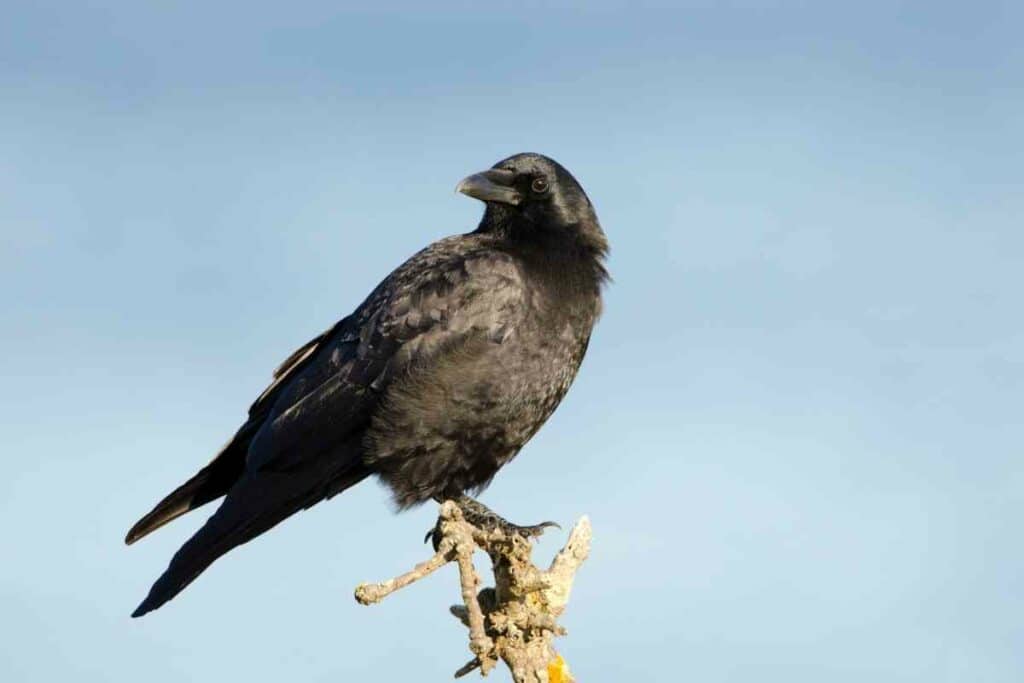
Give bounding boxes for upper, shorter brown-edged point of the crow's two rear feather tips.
[125,444,248,546]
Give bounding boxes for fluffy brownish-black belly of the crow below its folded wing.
[365,299,593,507]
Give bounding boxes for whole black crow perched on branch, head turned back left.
[125,153,609,616]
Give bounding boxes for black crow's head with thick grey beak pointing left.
[456,154,608,257]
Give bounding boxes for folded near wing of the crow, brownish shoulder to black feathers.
[241,241,526,471]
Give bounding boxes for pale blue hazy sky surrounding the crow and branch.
[0,0,1024,683]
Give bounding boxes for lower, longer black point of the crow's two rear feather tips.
[132,467,369,616]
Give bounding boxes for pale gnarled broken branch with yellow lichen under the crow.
[355,501,591,683]
